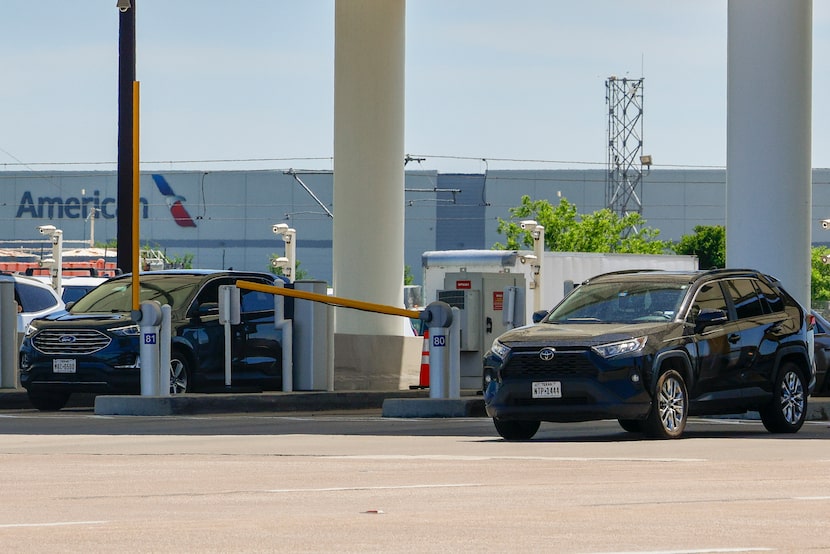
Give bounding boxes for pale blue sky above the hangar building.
[0,0,830,172]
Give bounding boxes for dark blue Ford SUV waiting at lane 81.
[19,270,282,410]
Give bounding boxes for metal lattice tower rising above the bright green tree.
[605,76,651,217]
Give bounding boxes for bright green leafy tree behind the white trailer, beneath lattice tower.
[493,195,670,254]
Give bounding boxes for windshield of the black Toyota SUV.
[544,280,688,323]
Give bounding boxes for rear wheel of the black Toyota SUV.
[759,362,807,433]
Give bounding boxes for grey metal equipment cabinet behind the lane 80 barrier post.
[436,271,527,390]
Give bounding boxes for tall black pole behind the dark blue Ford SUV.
[116,0,136,272]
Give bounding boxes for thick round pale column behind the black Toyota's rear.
[726,0,812,306]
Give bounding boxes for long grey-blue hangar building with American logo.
[0,169,830,284]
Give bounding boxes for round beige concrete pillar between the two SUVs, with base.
[332,0,406,335]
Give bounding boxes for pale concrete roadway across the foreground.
[0,409,830,553]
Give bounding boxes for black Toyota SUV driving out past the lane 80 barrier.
[484,270,816,440]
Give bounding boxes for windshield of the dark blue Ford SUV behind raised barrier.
[69,275,201,314]
